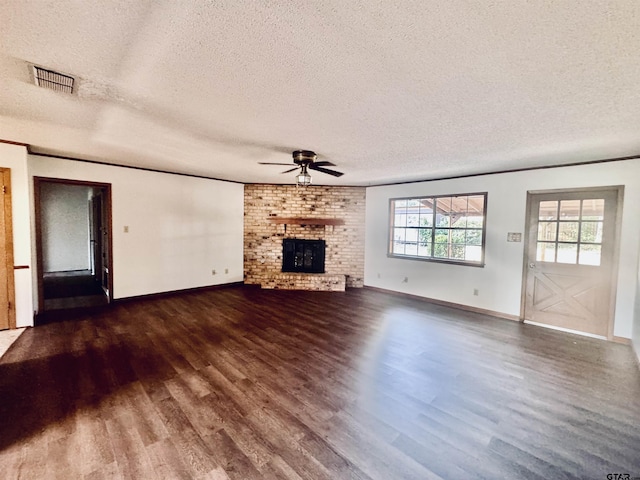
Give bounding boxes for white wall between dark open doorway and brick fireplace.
[28,155,244,304]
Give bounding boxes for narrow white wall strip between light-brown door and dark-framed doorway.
[0,143,33,327]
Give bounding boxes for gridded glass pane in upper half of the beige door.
[536,198,604,266]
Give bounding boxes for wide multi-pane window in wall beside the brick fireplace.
[389,193,487,266]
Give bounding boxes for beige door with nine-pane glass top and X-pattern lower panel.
[524,187,618,337]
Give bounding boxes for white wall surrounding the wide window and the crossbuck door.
[365,160,640,338]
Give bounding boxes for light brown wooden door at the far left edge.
[0,168,15,330]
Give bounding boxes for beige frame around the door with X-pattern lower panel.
[520,185,624,341]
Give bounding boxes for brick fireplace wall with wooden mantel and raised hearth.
[244,185,365,291]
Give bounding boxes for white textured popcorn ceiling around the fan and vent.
[0,0,640,185]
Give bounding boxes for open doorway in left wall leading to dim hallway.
[34,177,113,315]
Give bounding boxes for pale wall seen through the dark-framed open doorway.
[40,182,91,272]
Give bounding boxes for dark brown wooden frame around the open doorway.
[33,177,113,314]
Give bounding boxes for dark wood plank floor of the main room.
[0,287,640,480]
